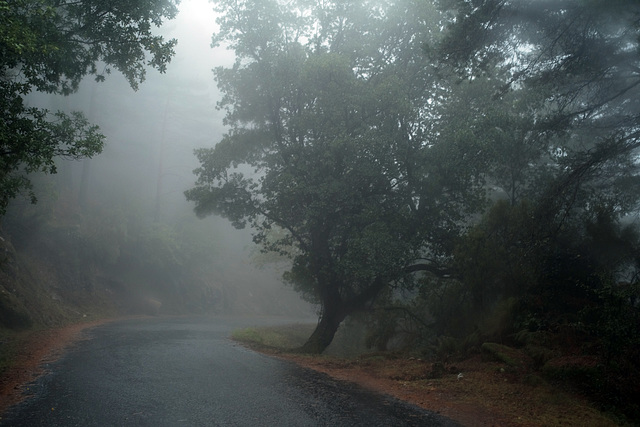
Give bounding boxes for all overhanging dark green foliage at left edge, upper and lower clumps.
[0,0,177,214]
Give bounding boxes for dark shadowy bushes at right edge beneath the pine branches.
[420,194,638,374]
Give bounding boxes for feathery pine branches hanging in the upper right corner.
[439,0,640,218]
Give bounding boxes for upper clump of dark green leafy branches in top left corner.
[0,0,177,94]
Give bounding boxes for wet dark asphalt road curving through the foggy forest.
[0,318,456,427]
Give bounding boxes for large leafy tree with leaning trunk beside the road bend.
[186,0,484,353]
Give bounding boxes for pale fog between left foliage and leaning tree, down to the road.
[5,0,314,317]
